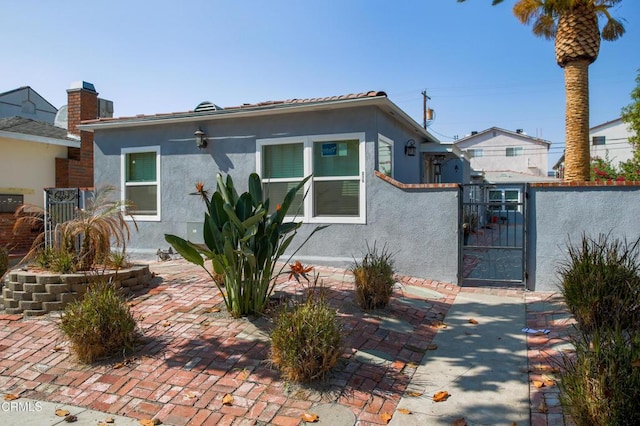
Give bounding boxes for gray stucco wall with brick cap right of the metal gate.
[528,186,640,291]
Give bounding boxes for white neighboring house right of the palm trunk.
[589,118,633,166]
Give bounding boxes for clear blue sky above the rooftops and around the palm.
[0,0,640,167]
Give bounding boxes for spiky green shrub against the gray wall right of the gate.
[560,235,640,333]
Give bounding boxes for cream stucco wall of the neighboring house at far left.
[0,138,67,207]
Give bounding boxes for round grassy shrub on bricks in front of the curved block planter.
[59,281,136,363]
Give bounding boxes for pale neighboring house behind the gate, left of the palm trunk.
[455,127,551,182]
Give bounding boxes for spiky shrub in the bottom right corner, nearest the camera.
[560,329,640,426]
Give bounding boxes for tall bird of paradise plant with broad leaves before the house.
[165,173,324,317]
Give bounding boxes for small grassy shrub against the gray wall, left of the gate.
[351,243,395,309]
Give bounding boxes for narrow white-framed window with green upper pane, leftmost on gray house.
[120,146,160,221]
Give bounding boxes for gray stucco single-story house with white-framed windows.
[79,92,470,282]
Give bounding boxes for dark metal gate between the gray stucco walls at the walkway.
[458,184,528,284]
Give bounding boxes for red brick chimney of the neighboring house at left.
[56,81,98,188]
